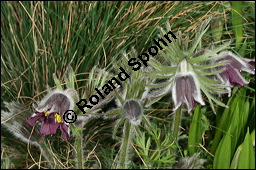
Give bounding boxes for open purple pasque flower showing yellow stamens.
[27,89,76,140]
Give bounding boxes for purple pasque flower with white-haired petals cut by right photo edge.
[216,51,255,97]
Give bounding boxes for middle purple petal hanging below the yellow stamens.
[40,118,59,136]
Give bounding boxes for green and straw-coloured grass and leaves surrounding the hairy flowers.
[1,1,255,168]
